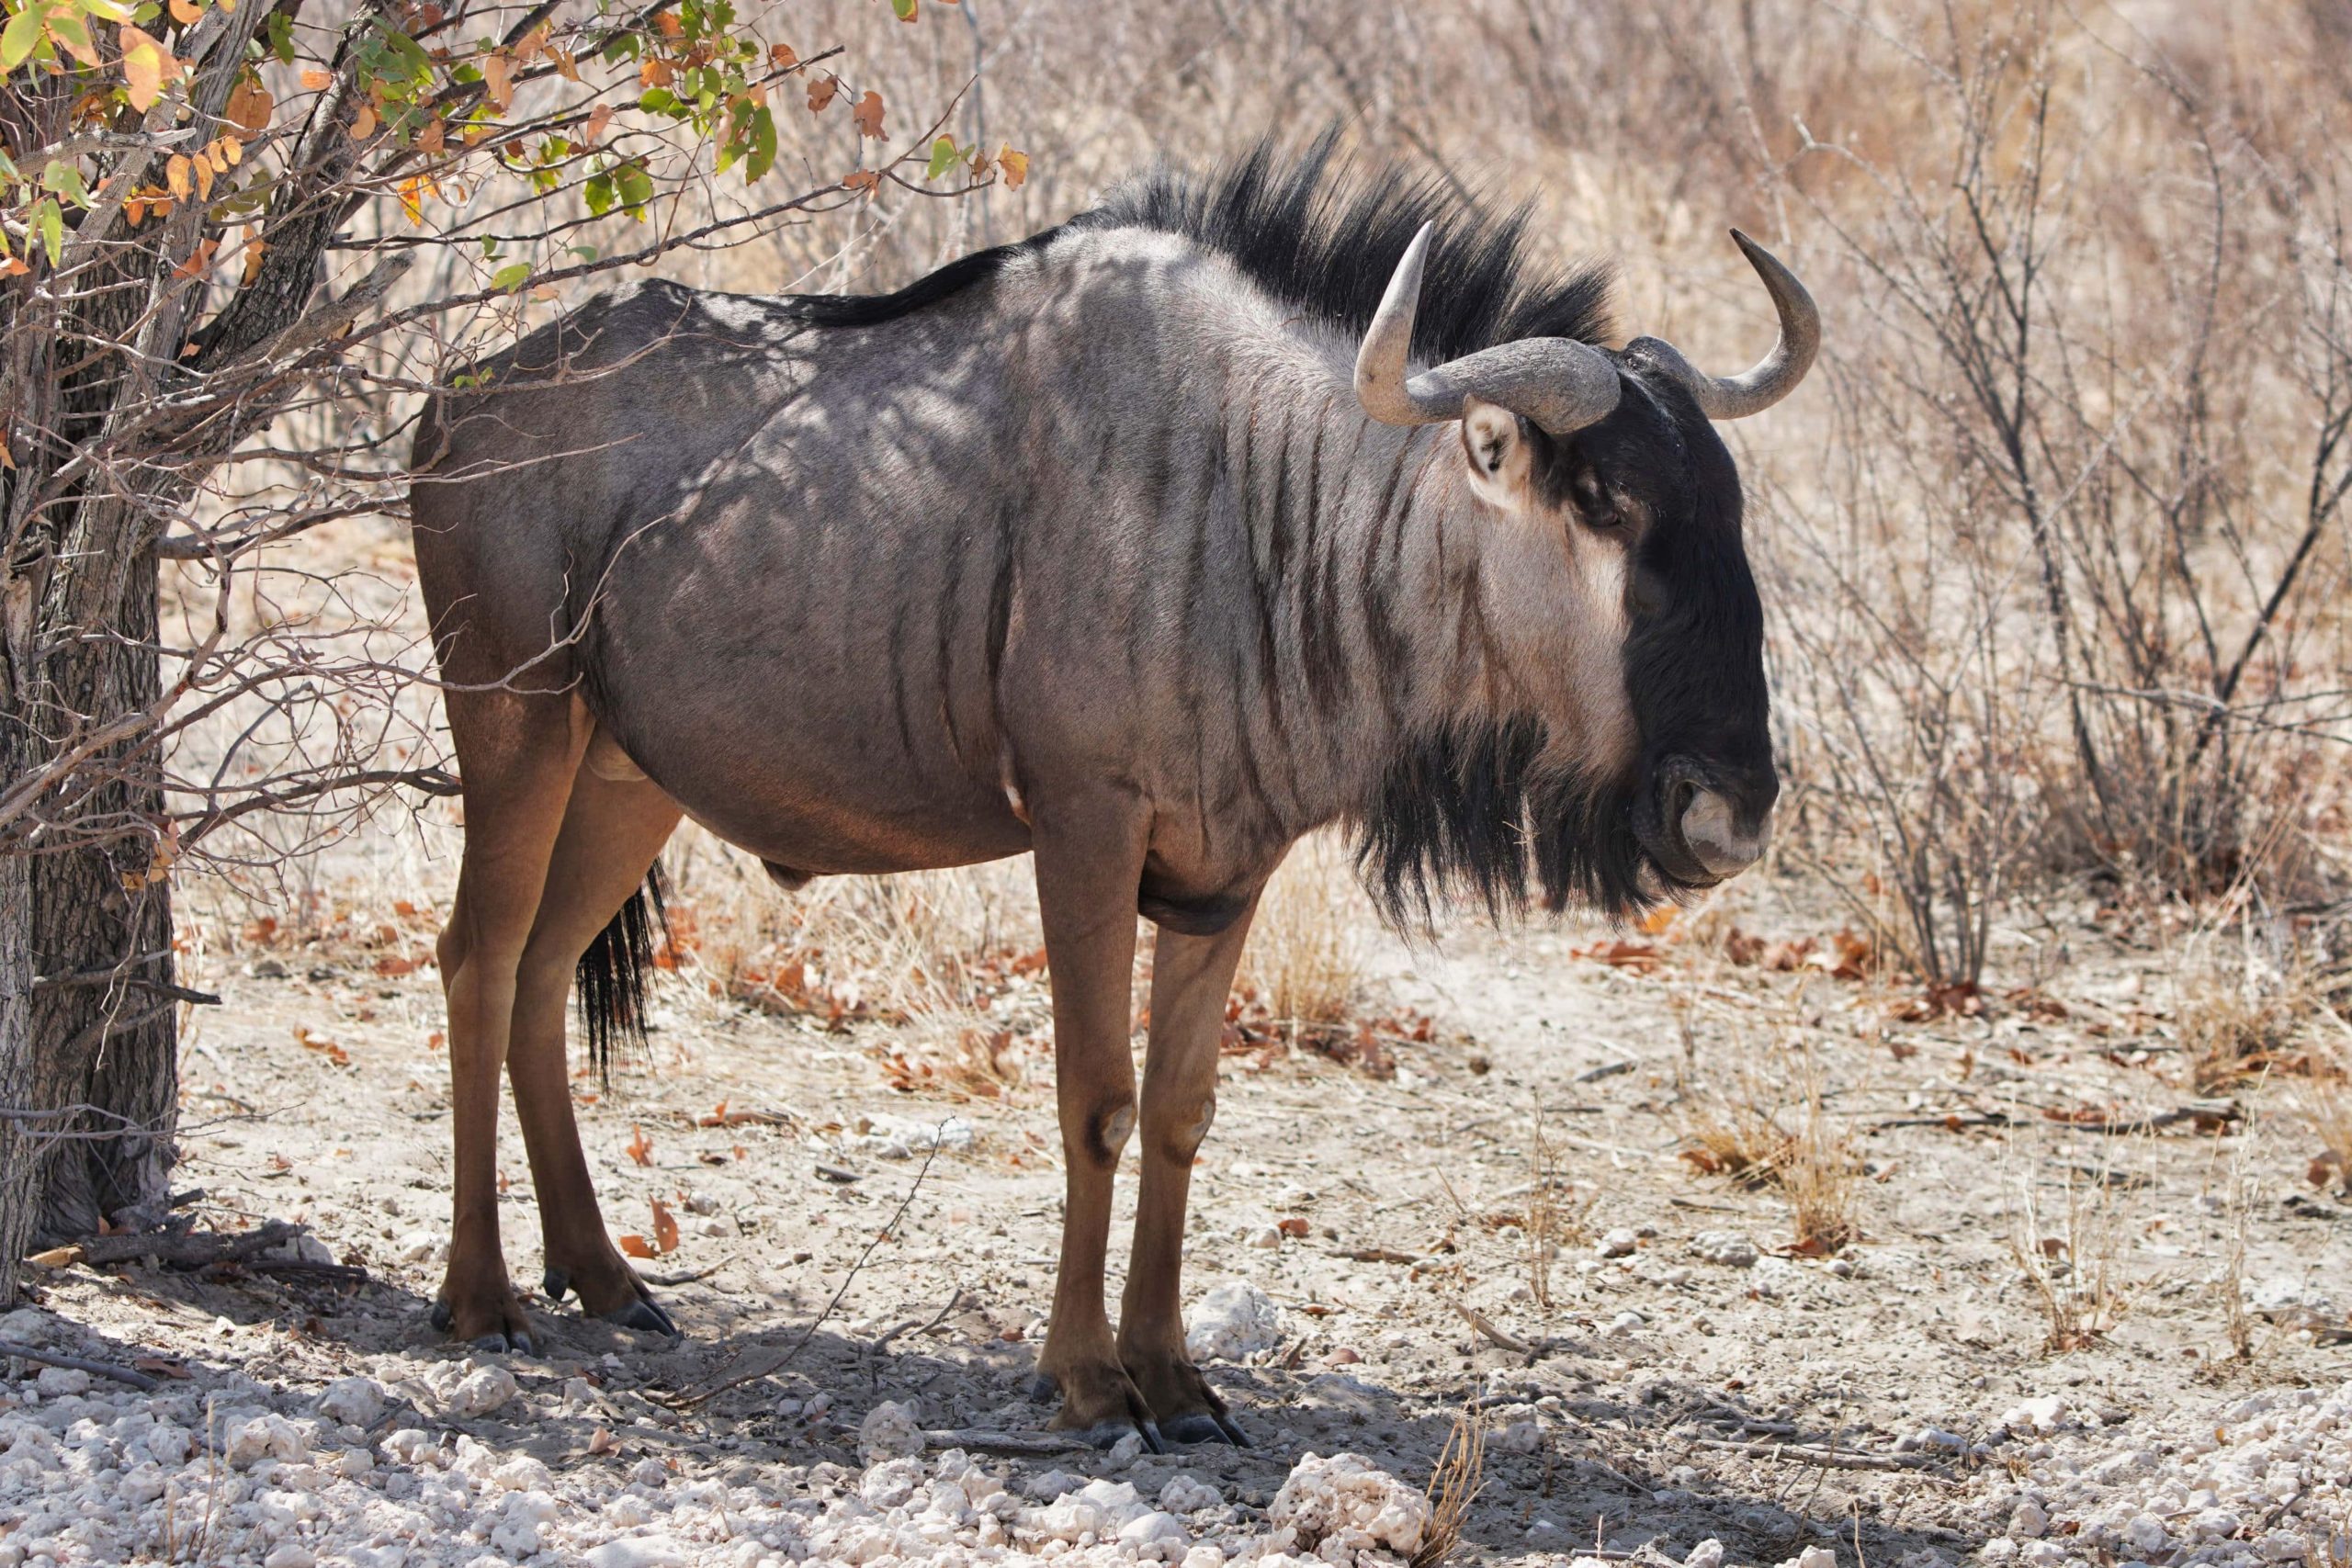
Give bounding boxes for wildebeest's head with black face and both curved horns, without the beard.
[1355,228,1820,888]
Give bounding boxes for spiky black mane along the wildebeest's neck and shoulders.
[788,131,1613,360]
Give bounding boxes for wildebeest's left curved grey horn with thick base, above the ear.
[1355,223,1618,434]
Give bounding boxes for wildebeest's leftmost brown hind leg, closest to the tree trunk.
[433,691,588,1352]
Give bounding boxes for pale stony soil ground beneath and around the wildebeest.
[0,869,2352,1568]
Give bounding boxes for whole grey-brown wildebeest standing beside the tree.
[414,146,1818,1443]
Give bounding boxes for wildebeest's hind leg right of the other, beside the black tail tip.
[505,743,680,1333]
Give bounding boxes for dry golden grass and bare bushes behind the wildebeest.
[172,0,2352,1135]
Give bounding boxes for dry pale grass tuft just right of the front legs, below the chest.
[1239,832,1369,1034]
